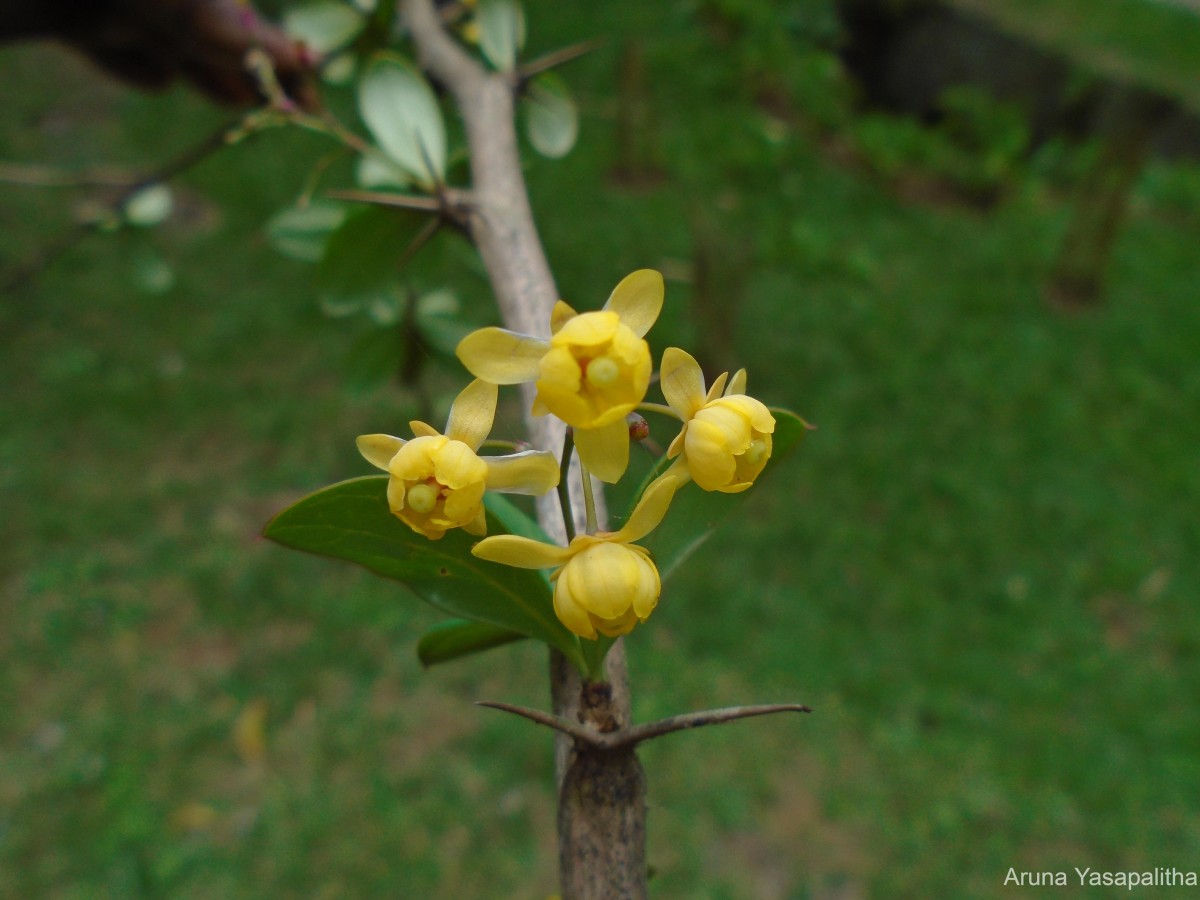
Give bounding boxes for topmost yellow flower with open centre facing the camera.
[457,269,662,484]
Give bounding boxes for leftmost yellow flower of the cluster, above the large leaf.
[358,380,558,540]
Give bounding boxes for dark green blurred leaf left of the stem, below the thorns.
[317,206,428,316]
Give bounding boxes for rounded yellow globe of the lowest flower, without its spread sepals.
[554,540,662,640]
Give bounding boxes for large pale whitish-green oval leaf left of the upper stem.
[359,53,446,191]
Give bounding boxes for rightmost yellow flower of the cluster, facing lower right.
[660,347,775,493]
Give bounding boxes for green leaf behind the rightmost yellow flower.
[637,409,809,580]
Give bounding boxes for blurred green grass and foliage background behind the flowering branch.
[0,0,1200,898]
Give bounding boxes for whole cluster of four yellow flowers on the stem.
[358,269,775,640]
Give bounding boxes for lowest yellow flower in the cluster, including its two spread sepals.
[470,476,682,641]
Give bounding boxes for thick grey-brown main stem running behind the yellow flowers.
[400,0,646,900]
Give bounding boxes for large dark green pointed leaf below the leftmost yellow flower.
[263,475,583,668]
